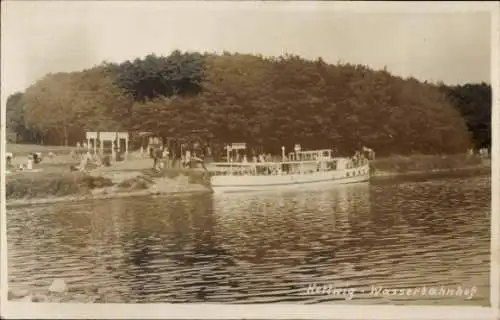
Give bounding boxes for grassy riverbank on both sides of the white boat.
[6,151,491,205]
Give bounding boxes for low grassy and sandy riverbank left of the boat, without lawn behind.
[6,167,210,206]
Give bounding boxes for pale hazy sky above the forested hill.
[1,0,491,109]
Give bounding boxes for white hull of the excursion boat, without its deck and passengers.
[211,165,370,193]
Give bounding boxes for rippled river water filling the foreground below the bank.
[7,176,491,306]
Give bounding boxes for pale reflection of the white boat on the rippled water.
[212,183,370,265]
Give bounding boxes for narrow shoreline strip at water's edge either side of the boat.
[6,164,491,208]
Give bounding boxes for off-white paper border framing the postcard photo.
[0,1,500,320]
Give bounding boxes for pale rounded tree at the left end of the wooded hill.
[24,68,132,146]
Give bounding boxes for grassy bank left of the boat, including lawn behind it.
[6,144,210,206]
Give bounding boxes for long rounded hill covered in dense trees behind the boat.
[7,51,491,155]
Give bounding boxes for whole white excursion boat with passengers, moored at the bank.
[209,147,370,193]
